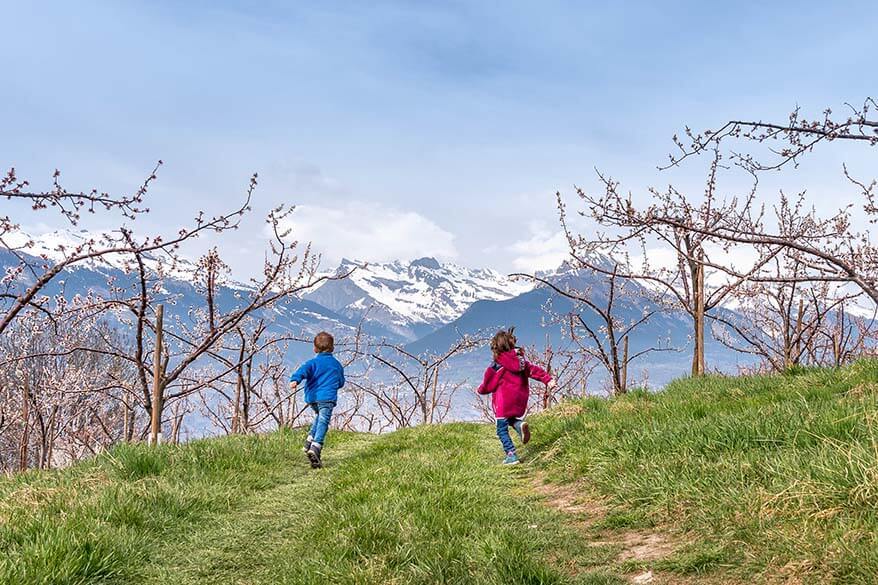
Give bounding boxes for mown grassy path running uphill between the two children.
[143,425,620,584]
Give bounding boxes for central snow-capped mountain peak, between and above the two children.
[305,258,533,340]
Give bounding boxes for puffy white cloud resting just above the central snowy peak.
[280,201,457,263]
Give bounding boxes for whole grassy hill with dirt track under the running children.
[0,362,878,584]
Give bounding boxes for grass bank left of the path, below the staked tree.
[0,433,364,584]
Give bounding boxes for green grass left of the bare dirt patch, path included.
[0,424,621,584]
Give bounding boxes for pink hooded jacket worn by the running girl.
[478,350,552,418]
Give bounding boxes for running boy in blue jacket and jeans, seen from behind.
[290,331,344,469]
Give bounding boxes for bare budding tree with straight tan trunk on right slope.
[557,146,780,376]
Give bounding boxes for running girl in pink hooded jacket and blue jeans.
[478,327,555,465]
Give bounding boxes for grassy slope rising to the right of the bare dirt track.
[530,361,878,583]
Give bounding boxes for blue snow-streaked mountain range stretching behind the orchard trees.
[0,232,756,400]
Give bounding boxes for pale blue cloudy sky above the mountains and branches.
[0,0,878,272]
